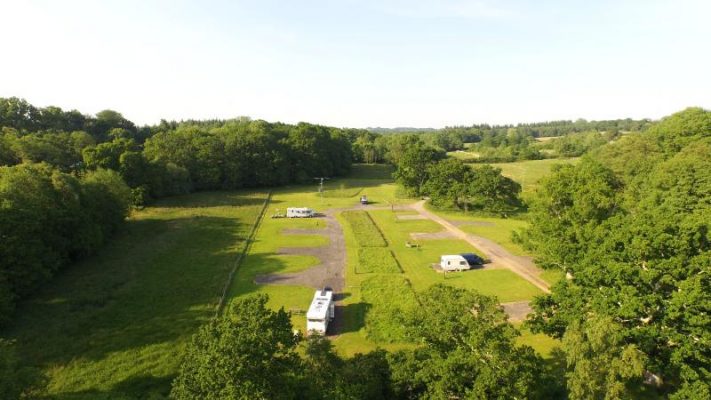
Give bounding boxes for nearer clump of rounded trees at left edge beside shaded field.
[0,164,130,322]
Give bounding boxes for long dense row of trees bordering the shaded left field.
[0,98,352,330]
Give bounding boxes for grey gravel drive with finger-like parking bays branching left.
[254,210,346,293]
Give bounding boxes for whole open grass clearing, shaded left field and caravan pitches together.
[4,162,556,399]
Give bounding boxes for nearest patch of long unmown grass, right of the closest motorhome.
[361,274,417,343]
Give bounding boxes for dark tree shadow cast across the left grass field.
[2,216,248,372]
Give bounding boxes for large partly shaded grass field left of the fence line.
[3,192,265,399]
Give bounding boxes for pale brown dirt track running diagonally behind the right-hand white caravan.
[411,200,551,293]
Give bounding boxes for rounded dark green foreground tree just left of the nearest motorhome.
[171,295,299,400]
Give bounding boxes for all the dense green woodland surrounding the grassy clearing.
[0,98,711,399]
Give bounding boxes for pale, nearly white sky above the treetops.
[0,0,711,127]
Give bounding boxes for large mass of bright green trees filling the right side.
[524,109,711,398]
